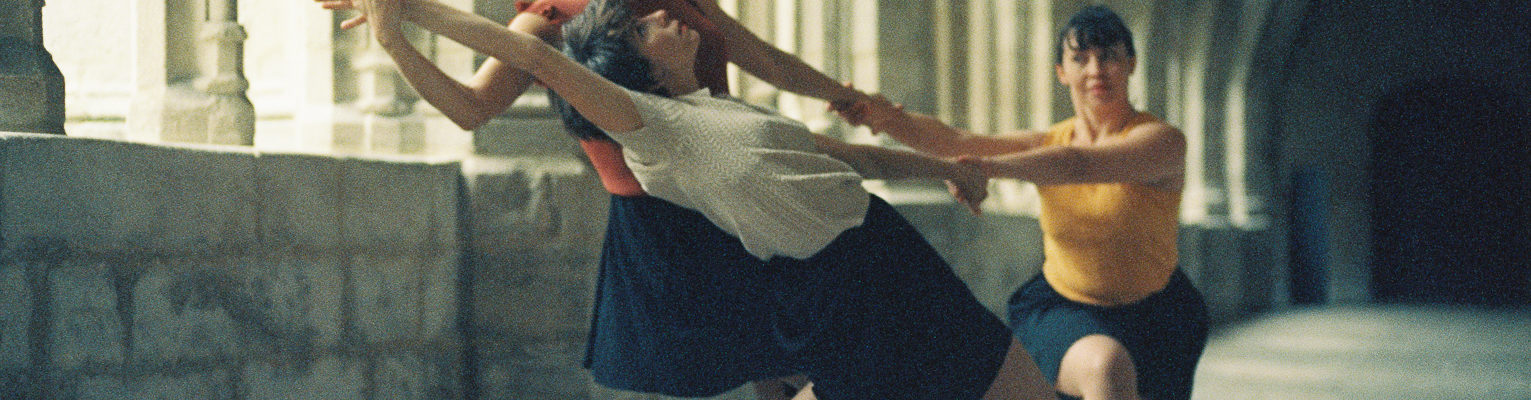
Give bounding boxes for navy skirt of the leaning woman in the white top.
[769,196,1010,400]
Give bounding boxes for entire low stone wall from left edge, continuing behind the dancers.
[0,133,1274,400]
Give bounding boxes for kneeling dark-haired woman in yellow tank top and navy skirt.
[842,6,1206,400]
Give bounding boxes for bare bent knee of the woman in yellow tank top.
[1058,334,1138,400]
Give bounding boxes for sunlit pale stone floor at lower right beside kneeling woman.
[1193,305,1531,400]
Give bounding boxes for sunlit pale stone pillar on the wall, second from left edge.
[127,0,256,146]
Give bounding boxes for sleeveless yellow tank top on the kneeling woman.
[1036,112,1180,305]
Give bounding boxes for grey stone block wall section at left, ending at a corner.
[0,135,464,398]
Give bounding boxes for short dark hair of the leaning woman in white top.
[548,0,669,139]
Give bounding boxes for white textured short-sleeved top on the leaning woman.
[608,90,870,259]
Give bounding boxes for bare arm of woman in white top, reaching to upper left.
[354,0,643,132]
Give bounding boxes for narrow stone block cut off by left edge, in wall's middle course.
[0,262,32,367]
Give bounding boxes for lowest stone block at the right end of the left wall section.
[372,356,462,400]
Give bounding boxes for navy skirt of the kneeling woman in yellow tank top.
[1009,270,1208,400]
